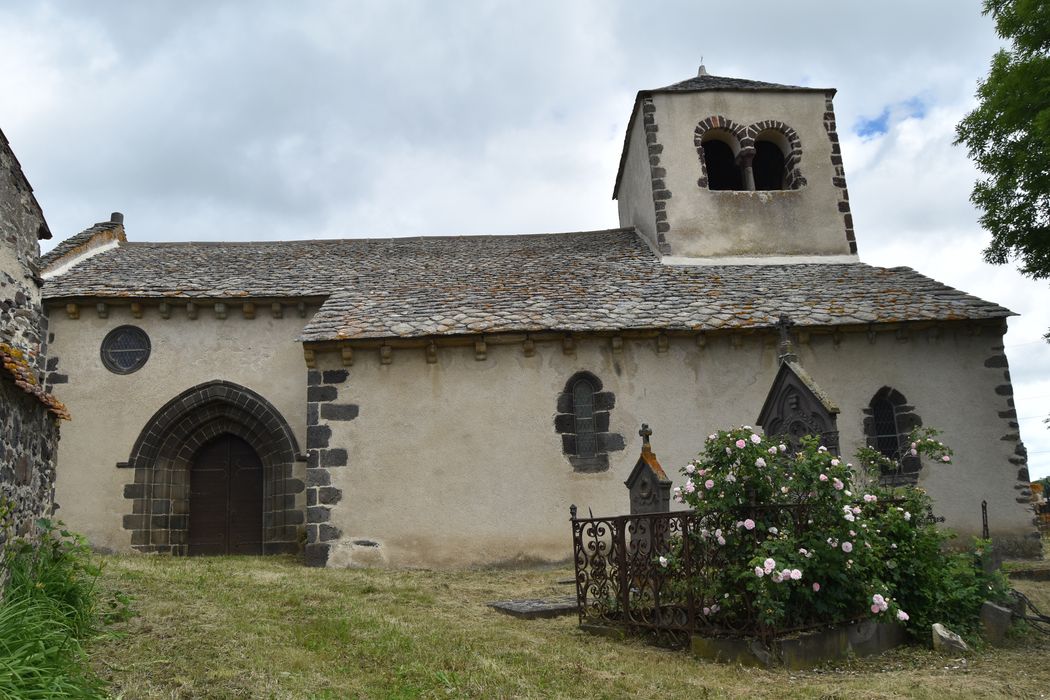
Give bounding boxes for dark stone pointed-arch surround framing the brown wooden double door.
[117,380,305,554]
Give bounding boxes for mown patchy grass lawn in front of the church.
[91,556,1050,699]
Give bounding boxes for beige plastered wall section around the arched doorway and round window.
[50,302,314,551]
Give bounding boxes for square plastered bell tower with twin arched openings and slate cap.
[612,66,857,264]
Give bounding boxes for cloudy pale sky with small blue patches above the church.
[0,0,1050,476]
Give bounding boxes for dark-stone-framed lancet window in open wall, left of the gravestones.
[554,372,625,471]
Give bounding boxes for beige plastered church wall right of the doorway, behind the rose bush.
[318,326,1032,567]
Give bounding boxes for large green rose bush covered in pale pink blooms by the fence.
[659,426,1005,638]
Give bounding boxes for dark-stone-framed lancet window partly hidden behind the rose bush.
[864,386,922,486]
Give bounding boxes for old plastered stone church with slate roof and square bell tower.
[26,68,1038,567]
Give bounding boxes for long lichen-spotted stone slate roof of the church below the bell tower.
[38,229,1010,341]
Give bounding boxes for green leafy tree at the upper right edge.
[956,0,1050,304]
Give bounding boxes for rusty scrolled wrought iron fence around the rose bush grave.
[571,501,907,646]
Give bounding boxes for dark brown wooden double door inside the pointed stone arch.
[189,434,263,555]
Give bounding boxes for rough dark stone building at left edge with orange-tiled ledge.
[0,132,61,558]
